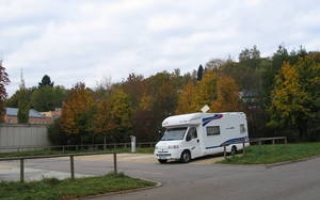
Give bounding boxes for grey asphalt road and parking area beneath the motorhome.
[0,155,320,200]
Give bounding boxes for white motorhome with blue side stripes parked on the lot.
[154,112,248,163]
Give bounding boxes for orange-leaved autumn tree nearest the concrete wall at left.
[61,82,95,143]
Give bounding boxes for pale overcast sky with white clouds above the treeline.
[0,0,320,95]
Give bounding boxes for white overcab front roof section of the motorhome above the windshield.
[162,112,212,127]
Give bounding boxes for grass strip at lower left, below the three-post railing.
[0,174,155,200]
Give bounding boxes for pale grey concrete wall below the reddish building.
[0,124,50,152]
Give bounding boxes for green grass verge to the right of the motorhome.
[220,143,320,164]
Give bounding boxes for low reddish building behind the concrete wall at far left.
[4,107,57,124]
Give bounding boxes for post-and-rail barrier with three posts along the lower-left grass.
[0,152,118,182]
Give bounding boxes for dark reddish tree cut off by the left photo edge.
[0,60,10,121]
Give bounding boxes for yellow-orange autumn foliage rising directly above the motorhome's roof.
[176,70,240,114]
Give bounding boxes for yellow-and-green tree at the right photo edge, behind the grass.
[268,58,320,139]
